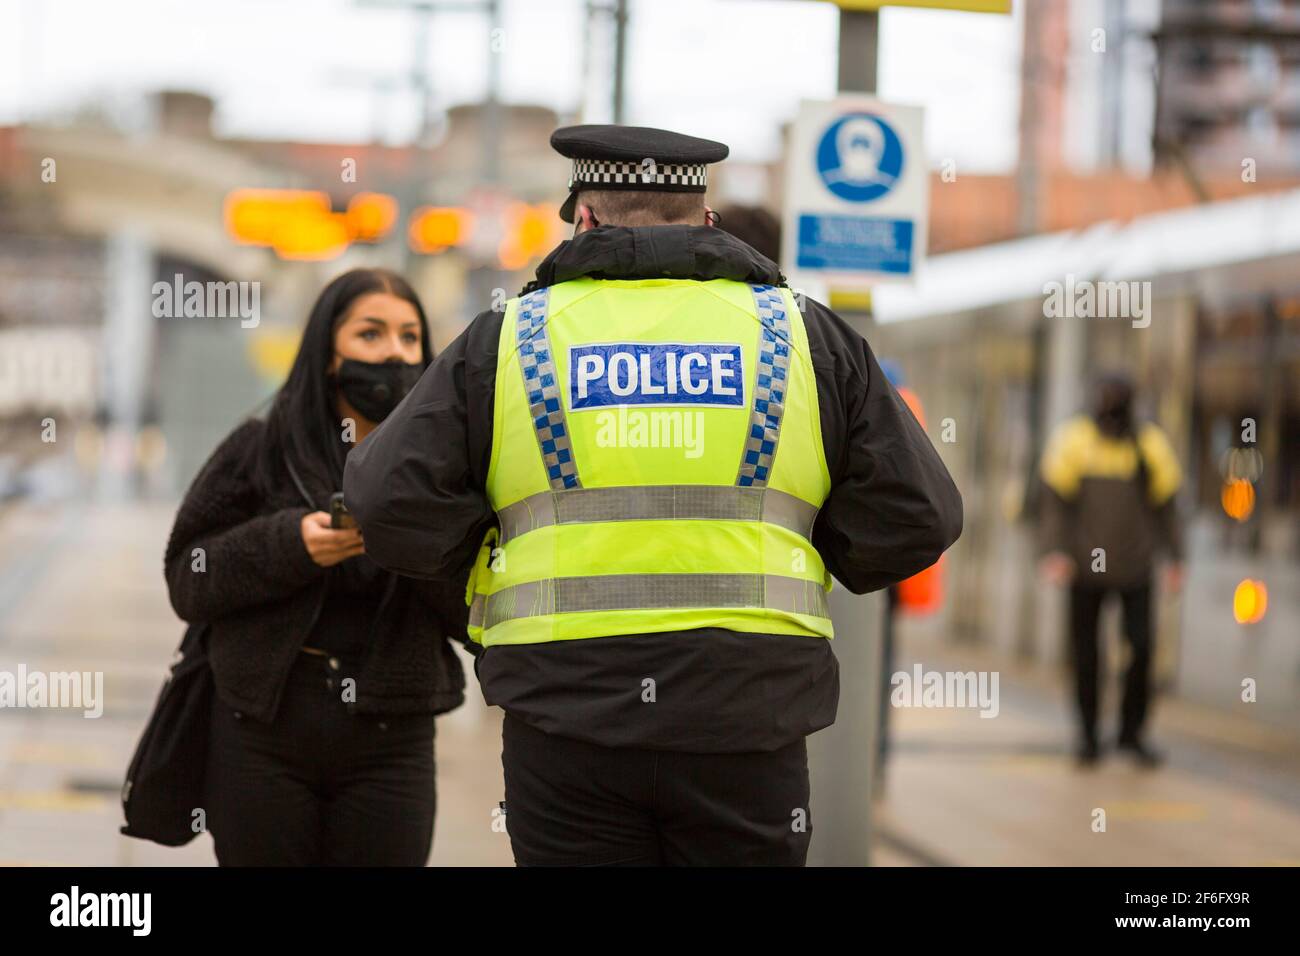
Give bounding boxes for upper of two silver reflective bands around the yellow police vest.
[497,485,818,544]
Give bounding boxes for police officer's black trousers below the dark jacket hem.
[502,704,813,866]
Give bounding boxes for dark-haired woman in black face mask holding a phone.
[165,269,467,866]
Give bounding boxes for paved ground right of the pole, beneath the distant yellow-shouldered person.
[868,632,1300,866]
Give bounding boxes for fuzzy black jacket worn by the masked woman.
[164,420,468,722]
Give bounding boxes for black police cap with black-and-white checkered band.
[551,125,729,222]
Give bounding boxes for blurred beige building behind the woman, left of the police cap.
[0,91,567,497]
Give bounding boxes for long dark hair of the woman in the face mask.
[257,269,433,509]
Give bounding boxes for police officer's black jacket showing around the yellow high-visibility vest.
[343,226,962,753]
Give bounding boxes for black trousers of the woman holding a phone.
[207,653,437,866]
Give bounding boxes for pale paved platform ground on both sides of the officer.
[0,503,1300,866]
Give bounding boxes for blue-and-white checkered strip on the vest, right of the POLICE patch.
[736,285,790,488]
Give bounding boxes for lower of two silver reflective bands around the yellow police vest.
[488,574,831,628]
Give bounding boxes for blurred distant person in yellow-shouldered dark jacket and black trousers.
[1040,372,1183,766]
